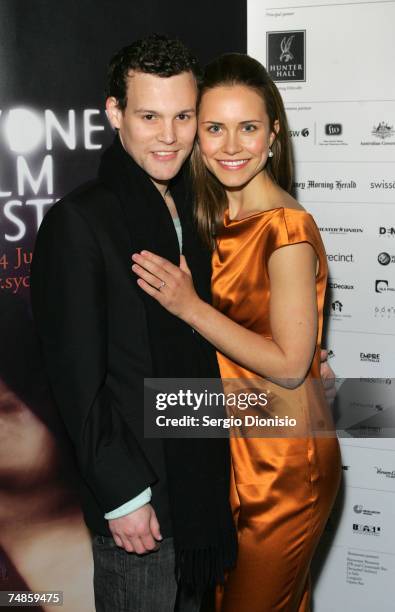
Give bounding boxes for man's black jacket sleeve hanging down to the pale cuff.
[31,201,156,513]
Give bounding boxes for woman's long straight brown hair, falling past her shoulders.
[191,53,293,249]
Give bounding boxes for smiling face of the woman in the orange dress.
[198,85,278,188]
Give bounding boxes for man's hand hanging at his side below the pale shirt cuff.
[108,504,162,555]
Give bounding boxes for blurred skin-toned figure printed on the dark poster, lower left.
[0,293,95,612]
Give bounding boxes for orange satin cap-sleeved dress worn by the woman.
[212,208,341,612]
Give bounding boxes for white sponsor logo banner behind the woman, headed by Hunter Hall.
[247,0,395,612]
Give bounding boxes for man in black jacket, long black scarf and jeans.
[32,36,336,612]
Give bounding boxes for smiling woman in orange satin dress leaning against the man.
[133,54,340,612]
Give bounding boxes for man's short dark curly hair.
[106,34,201,110]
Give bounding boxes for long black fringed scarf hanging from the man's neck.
[99,137,237,588]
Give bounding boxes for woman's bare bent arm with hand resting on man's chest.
[133,243,317,388]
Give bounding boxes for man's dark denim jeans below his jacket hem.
[92,536,201,612]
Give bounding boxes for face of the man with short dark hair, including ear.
[106,72,197,190]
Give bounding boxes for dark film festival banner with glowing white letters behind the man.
[0,0,246,612]
